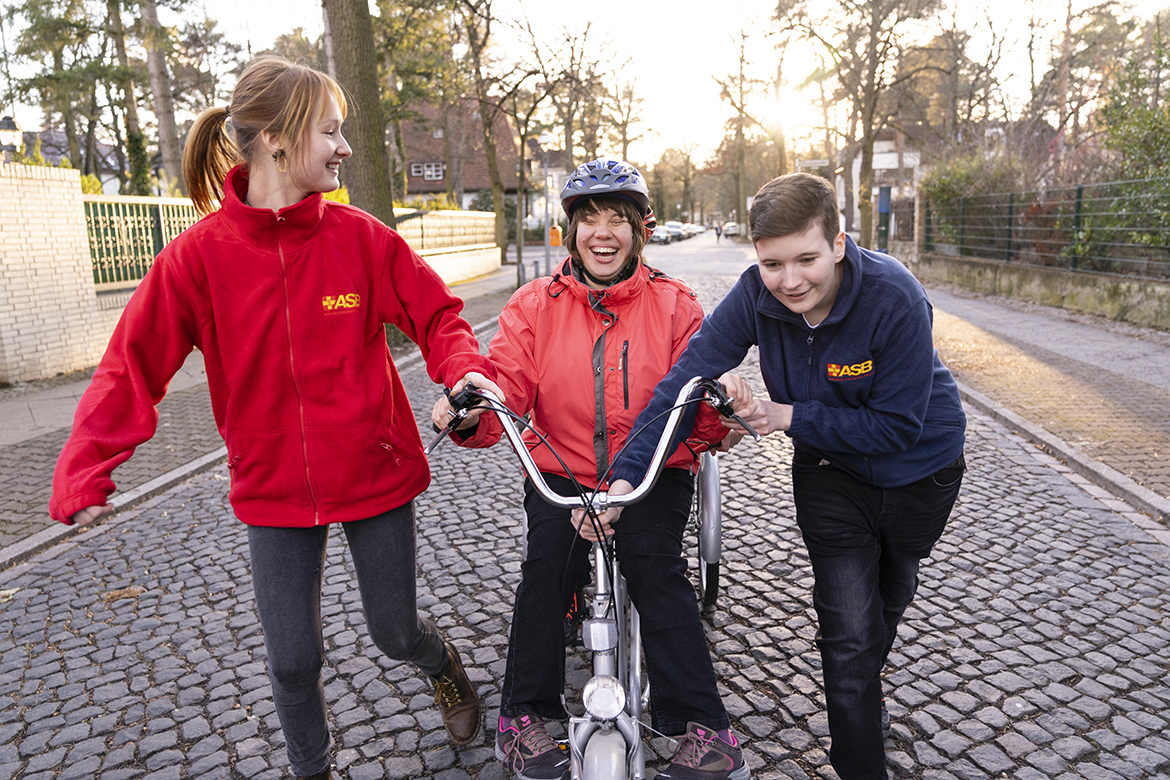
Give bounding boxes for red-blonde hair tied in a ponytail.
[183,56,346,214]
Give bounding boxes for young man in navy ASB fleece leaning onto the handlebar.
[603,173,966,780]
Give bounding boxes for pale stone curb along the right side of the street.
[956,382,1170,532]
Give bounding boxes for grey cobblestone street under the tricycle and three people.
[0,239,1170,780]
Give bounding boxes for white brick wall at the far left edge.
[0,164,110,382]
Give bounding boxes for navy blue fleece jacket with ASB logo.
[613,239,966,488]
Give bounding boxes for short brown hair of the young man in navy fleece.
[748,173,841,244]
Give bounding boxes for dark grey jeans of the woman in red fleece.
[248,504,447,778]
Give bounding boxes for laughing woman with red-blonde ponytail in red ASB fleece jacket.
[49,57,498,778]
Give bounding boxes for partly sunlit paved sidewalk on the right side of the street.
[932,288,1170,509]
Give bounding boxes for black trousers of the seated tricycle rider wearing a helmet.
[500,469,730,734]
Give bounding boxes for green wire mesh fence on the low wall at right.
[923,179,1170,279]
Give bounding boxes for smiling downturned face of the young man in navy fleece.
[756,222,845,325]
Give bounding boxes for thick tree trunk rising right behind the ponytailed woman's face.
[324,0,394,227]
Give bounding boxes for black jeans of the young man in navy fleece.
[792,453,965,780]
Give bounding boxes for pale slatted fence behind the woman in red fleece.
[82,195,496,292]
